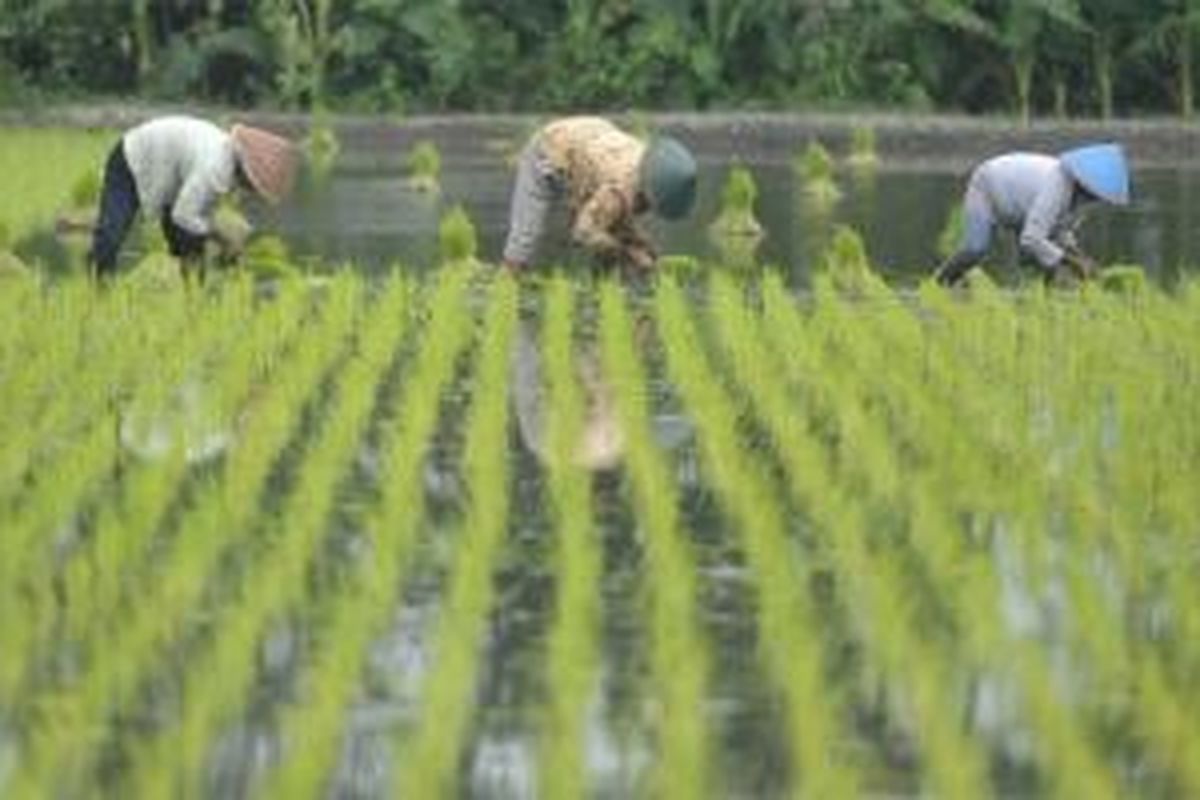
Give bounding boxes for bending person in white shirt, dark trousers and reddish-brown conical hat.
[89,116,296,277]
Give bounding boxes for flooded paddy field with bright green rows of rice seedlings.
[7,120,1200,799]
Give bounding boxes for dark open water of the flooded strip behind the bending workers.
[270,117,1200,284]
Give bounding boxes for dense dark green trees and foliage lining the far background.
[0,0,1200,118]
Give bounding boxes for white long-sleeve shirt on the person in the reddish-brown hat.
[122,116,236,236]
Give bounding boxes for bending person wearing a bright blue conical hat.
[937,144,1129,285]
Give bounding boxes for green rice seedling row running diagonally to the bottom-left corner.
[9,273,362,793]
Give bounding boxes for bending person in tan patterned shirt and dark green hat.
[504,116,696,270]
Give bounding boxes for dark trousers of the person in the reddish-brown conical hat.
[88,142,204,277]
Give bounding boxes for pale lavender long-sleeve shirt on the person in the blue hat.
[968,152,1081,266]
